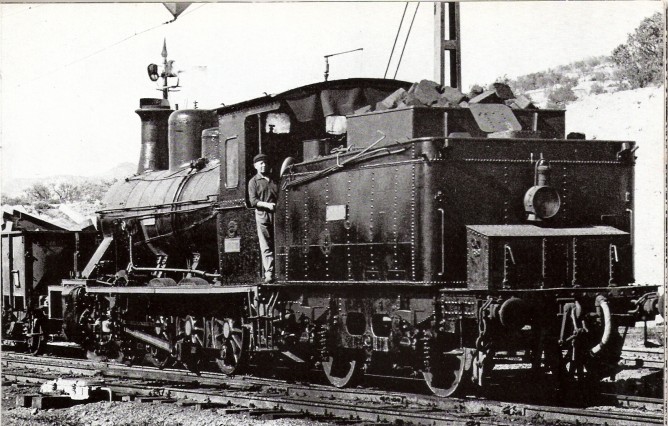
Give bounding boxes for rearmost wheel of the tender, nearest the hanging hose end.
[422,348,472,397]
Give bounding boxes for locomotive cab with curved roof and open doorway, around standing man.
[217,79,408,283]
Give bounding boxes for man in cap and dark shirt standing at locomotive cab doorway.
[248,153,278,283]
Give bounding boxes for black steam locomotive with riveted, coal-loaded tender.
[49,79,657,396]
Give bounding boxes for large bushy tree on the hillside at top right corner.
[612,12,663,89]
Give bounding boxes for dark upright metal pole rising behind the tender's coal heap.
[434,2,462,90]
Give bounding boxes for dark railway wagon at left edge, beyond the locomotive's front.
[0,210,97,353]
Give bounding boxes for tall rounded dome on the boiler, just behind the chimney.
[168,109,217,170]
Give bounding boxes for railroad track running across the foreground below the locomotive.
[2,353,663,425]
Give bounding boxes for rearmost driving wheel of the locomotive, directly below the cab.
[212,318,250,375]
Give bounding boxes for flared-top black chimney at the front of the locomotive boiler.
[135,98,173,174]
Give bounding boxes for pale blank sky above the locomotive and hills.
[0,1,662,181]
